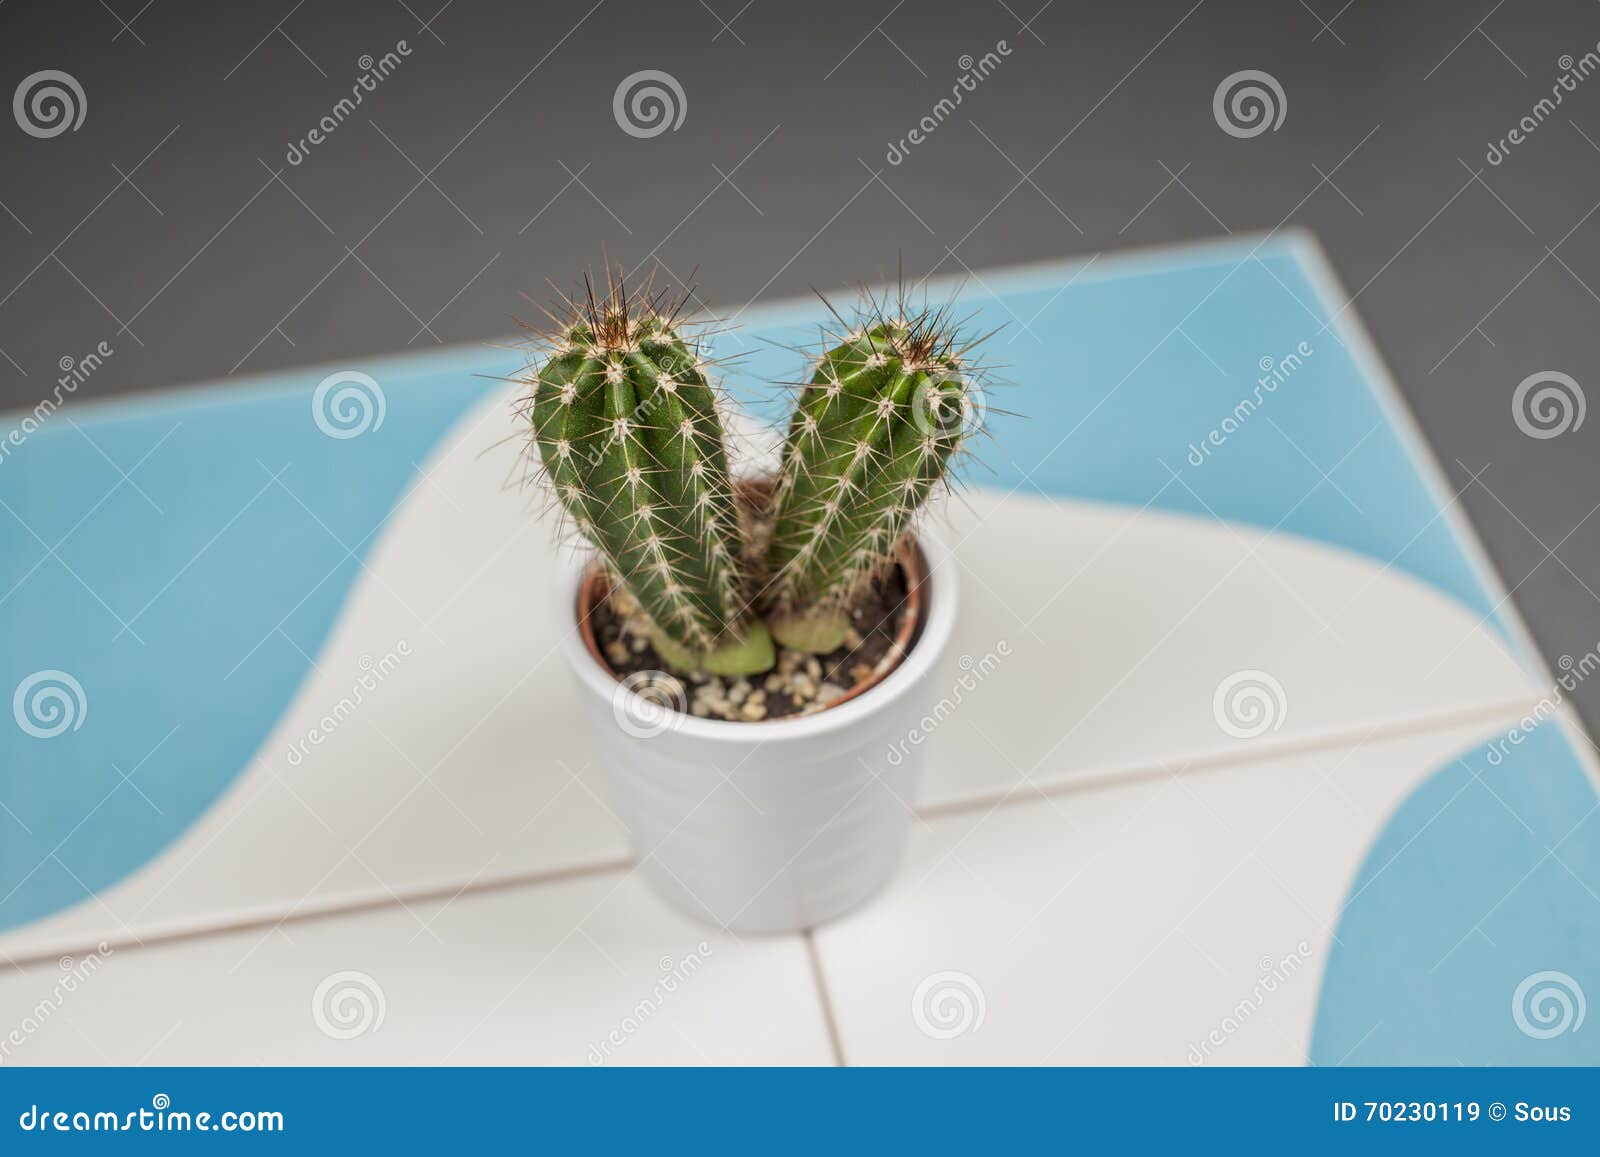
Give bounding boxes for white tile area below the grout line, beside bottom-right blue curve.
[818,723,1493,1064]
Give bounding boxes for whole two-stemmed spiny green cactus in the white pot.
[525,270,979,688]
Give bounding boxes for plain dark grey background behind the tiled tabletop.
[0,0,1600,730]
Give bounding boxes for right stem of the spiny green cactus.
[768,294,976,653]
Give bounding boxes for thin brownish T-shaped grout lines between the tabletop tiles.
[0,687,1538,966]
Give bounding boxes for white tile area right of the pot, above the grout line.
[923,491,1539,803]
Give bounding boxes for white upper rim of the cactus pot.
[560,530,957,746]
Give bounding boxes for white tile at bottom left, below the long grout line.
[0,871,832,1066]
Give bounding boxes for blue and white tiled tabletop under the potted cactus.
[0,237,1600,1064]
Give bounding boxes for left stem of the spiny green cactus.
[528,270,774,675]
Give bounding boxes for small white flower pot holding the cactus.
[558,533,957,933]
